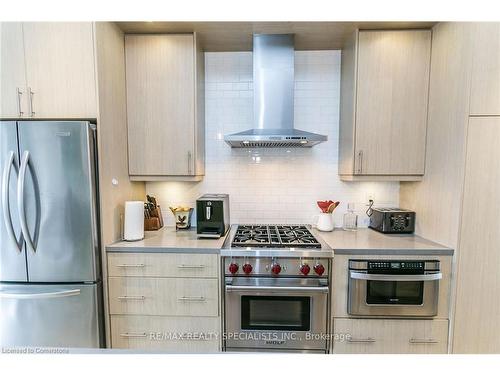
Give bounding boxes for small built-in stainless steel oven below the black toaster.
[348,259,443,317]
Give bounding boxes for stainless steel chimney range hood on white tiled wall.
[224,34,328,148]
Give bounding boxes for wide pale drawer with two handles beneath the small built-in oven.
[333,319,448,354]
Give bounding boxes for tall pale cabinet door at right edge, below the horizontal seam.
[453,117,500,353]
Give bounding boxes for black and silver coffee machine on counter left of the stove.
[196,194,230,238]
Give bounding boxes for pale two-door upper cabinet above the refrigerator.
[0,22,97,119]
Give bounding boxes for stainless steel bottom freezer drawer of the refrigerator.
[0,284,102,348]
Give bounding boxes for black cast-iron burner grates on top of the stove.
[231,225,321,248]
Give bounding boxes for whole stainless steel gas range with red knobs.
[221,225,333,353]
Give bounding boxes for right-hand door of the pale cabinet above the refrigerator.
[23,22,97,119]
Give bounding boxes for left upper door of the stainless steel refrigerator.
[0,121,28,281]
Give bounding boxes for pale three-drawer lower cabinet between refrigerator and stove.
[108,251,221,353]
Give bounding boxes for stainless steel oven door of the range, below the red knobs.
[224,277,329,353]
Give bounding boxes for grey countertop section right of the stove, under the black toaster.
[314,228,453,255]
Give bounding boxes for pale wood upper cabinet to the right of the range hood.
[339,30,431,181]
